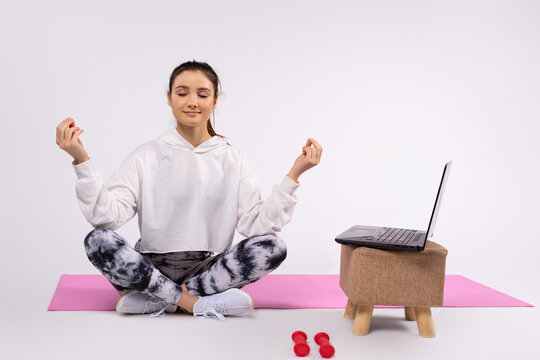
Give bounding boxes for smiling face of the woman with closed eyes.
[168,70,217,129]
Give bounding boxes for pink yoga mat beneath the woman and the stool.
[48,274,533,311]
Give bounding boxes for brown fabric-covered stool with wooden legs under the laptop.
[339,240,448,337]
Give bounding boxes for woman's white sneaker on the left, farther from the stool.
[116,290,177,316]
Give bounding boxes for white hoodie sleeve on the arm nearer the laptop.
[236,154,300,237]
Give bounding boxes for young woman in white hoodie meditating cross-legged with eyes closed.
[56,61,322,320]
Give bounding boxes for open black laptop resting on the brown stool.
[336,161,452,251]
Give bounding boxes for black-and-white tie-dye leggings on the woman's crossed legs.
[84,228,287,304]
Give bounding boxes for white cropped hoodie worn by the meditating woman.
[72,127,300,253]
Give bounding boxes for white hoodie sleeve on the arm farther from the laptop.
[71,153,139,231]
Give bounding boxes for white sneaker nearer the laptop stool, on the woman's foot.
[193,288,255,320]
